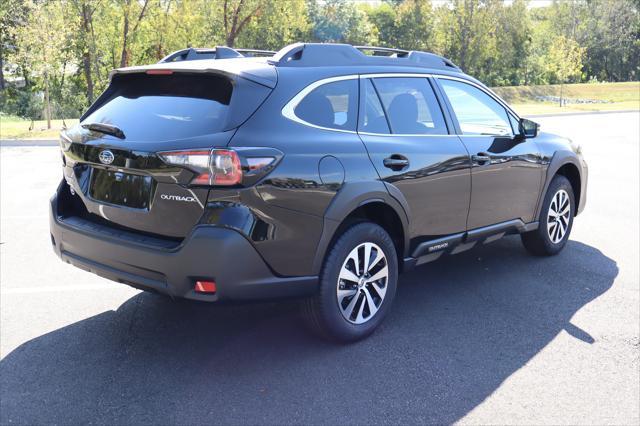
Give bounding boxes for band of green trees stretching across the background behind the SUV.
[0,0,640,119]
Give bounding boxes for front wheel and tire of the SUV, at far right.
[521,175,576,256]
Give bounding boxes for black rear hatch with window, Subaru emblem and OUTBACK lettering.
[61,60,275,238]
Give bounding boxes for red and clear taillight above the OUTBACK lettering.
[158,149,242,186]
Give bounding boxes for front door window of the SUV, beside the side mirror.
[440,79,512,136]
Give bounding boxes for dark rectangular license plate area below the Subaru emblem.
[89,168,155,210]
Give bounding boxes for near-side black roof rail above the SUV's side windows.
[269,43,461,72]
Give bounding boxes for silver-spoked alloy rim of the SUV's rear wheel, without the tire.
[337,242,389,324]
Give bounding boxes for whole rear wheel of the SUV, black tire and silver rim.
[302,222,398,342]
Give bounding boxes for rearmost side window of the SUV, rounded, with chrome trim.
[294,79,358,131]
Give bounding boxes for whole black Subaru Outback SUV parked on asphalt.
[50,44,587,341]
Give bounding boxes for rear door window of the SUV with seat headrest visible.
[373,77,448,135]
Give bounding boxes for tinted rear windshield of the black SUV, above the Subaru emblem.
[82,73,269,141]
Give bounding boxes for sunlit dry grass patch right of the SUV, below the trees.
[493,81,640,115]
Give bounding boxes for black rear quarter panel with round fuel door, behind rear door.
[229,69,378,275]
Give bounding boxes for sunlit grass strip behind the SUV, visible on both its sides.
[0,81,640,139]
